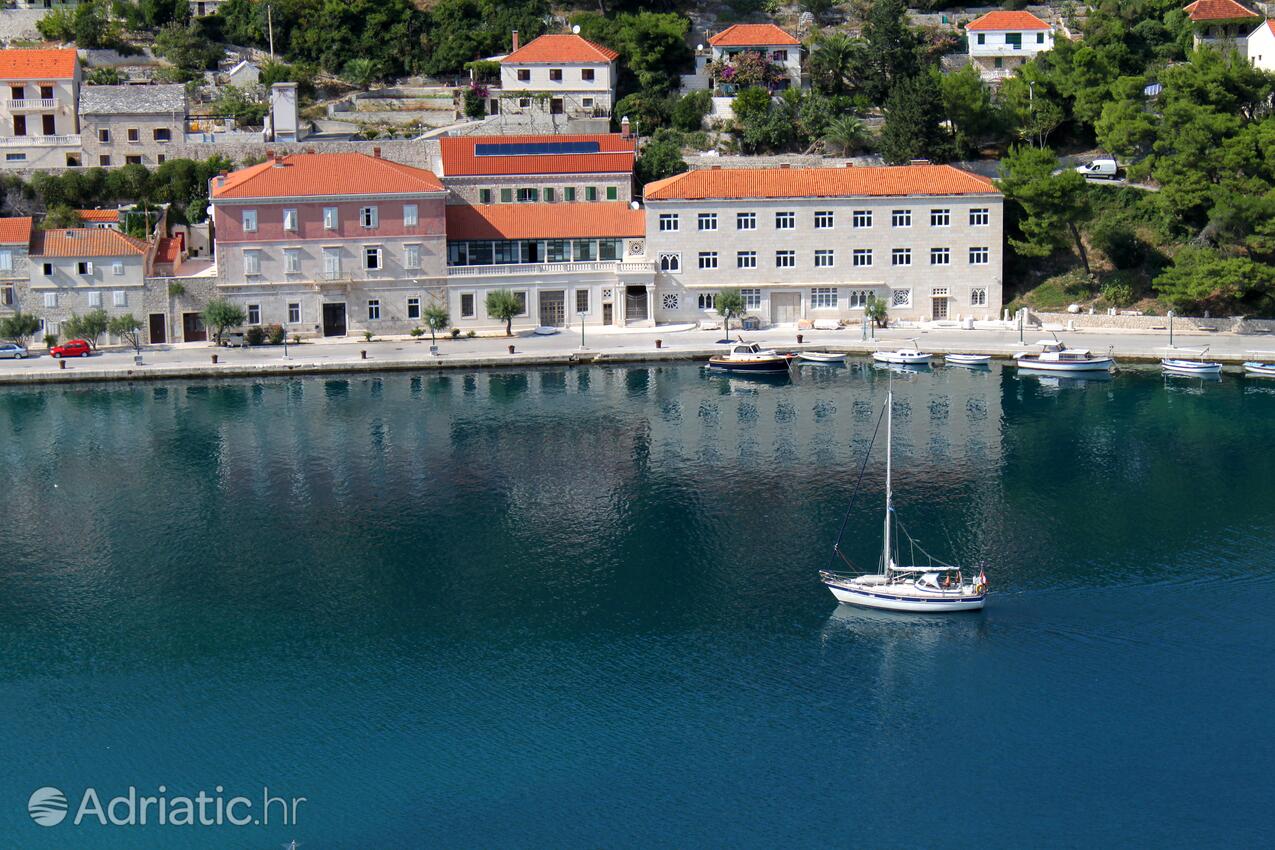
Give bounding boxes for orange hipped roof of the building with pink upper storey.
[212,153,442,198]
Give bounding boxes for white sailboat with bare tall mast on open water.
[819,389,987,613]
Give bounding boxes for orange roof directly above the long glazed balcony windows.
[448,201,646,240]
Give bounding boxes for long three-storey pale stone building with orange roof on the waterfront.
[645,163,1003,325]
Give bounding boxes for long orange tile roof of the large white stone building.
[645,164,1000,201]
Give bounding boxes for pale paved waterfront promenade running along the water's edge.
[0,322,1275,384]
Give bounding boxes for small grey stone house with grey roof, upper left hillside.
[79,85,186,167]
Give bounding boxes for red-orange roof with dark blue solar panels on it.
[439,133,636,177]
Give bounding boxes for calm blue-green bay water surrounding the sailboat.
[0,364,1275,850]
